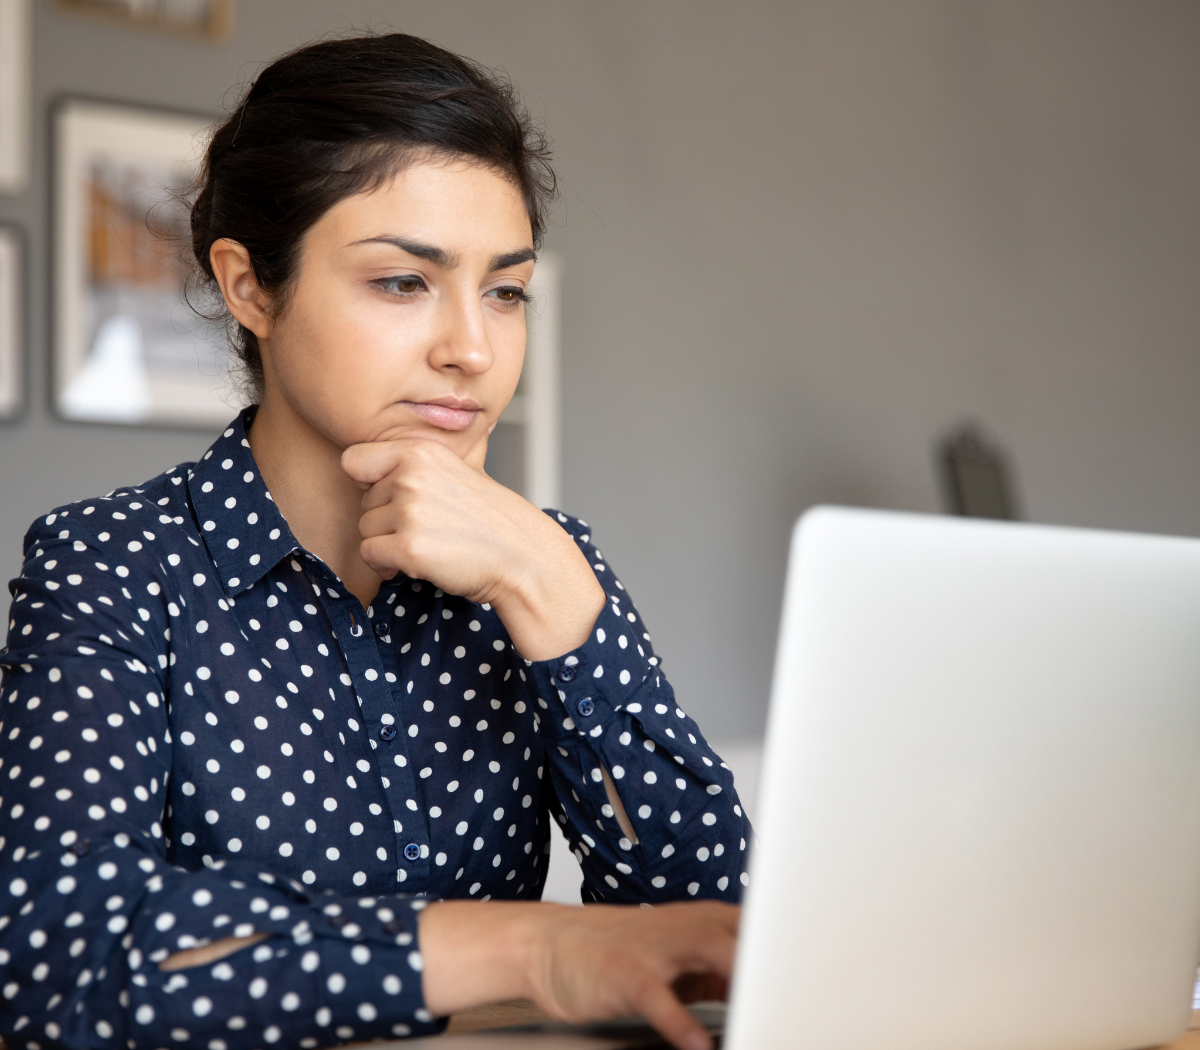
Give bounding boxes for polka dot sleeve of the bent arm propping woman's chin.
[523,511,751,904]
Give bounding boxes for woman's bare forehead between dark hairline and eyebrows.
[308,160,533,257]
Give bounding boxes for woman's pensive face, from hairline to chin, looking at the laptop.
[259,161,534,463]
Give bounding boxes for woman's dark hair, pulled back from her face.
[191,32,557,400]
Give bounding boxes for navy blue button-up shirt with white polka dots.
[0,409,750,1050]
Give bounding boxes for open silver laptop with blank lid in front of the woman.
[405,508,1200,1050]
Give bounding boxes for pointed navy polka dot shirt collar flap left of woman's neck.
[187,404,300,598]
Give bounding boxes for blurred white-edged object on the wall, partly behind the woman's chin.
[487,251,563,508]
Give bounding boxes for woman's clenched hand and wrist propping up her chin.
[342,438,605,660]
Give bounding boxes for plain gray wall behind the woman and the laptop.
[0,0,1200,738]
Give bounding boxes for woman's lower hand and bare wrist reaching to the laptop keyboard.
[420,901,740,1050]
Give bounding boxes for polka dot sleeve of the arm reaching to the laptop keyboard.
[0,512,442,1050]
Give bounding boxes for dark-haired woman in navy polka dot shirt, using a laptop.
[0,35,750,1050]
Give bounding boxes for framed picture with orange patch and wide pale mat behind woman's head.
[52,100,241,428]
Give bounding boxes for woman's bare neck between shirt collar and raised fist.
[247,391,380,608]
